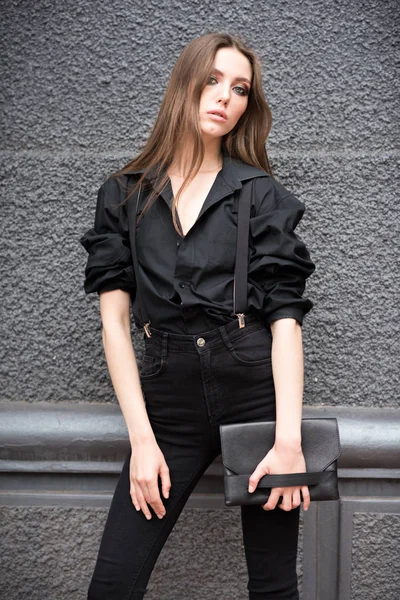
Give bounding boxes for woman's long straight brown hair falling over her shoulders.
[113,33,272,233]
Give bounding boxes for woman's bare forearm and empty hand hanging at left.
[100,290,171,519]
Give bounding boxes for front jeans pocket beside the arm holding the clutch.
[230,327,272,366]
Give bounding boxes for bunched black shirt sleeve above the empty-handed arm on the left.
[80,178,136,298]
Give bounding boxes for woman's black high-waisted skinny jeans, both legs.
[88,317,299,600]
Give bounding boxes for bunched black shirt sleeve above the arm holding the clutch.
[249,179,315,324]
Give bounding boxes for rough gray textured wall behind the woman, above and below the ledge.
[0,0,400,600]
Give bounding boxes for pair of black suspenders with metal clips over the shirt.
[131,180,253,337]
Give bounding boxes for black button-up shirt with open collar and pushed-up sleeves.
[80,154,315,335]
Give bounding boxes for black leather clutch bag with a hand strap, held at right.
[220,418,340,506]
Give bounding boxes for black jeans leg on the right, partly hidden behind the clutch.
[213,328,299,600]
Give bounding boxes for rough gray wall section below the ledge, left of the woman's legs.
[0,507,106,600]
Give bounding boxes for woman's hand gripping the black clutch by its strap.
[249,446,310,510]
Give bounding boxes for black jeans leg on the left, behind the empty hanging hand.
[89,339,222,600]
